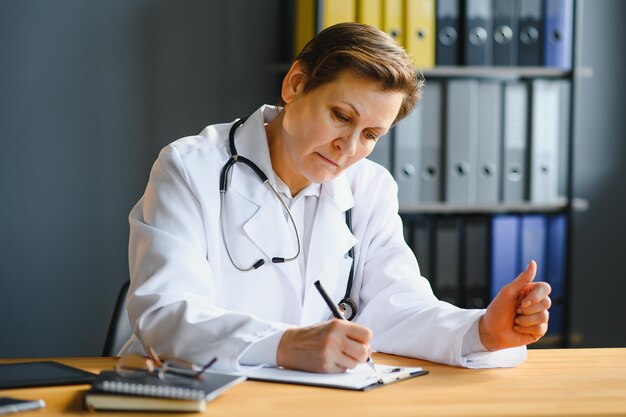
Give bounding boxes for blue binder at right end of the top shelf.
[543,0,574,70]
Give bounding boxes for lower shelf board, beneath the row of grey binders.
[399,198,568,215]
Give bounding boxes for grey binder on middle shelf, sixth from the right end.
[393,104,422,207]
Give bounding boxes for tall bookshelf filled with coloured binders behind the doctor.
[286,0,572,346]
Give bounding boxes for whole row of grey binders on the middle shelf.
[368,79,570,206]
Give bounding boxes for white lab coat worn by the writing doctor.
[122,106,526,369]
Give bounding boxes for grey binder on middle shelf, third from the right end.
[474,81,502,203]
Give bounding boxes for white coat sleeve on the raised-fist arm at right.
[355,169,526,368]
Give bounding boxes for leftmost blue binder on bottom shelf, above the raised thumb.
[490,214,520,299]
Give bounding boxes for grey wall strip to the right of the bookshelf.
[571,0,626,347]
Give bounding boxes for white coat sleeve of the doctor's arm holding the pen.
[126,145,288,370]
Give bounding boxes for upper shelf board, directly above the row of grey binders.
[422,66,572,80]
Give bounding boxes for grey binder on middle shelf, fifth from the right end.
[418,81,444,202]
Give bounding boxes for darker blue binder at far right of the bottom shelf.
[546,214,567,335]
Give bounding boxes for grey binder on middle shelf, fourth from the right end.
[445,80,478,204]
